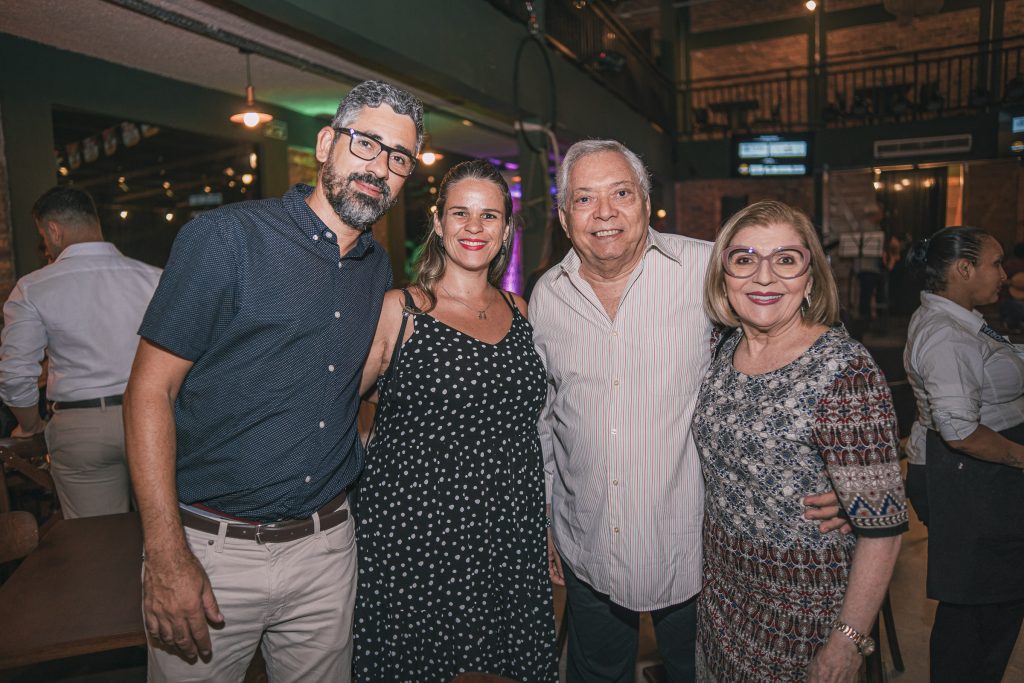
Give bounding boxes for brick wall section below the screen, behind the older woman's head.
[676,178,814,240]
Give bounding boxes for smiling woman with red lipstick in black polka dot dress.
[353,161,558,683]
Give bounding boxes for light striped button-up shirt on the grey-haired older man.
[529,228,712,611]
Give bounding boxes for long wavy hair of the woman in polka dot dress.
[413,159,515,311]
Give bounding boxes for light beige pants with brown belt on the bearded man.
[143,505,356,683]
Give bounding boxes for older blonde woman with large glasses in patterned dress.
[693,202,907,683]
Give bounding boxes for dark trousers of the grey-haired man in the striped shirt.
[562,562,697,683]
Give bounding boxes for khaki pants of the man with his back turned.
[46,405,131,519]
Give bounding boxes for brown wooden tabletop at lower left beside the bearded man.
[0,512,145,669]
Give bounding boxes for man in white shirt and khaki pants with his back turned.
[0,187,161,518]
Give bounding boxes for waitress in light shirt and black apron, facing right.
[903,227,1024,683]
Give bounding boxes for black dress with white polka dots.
[353,292,558,683]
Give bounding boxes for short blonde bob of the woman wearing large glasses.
[705,200,839,328]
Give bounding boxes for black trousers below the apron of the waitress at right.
[931,601,1024,683]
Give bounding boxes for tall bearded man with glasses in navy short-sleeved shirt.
[124,81,423,682]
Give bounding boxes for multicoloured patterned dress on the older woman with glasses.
[693,326,907,683]
